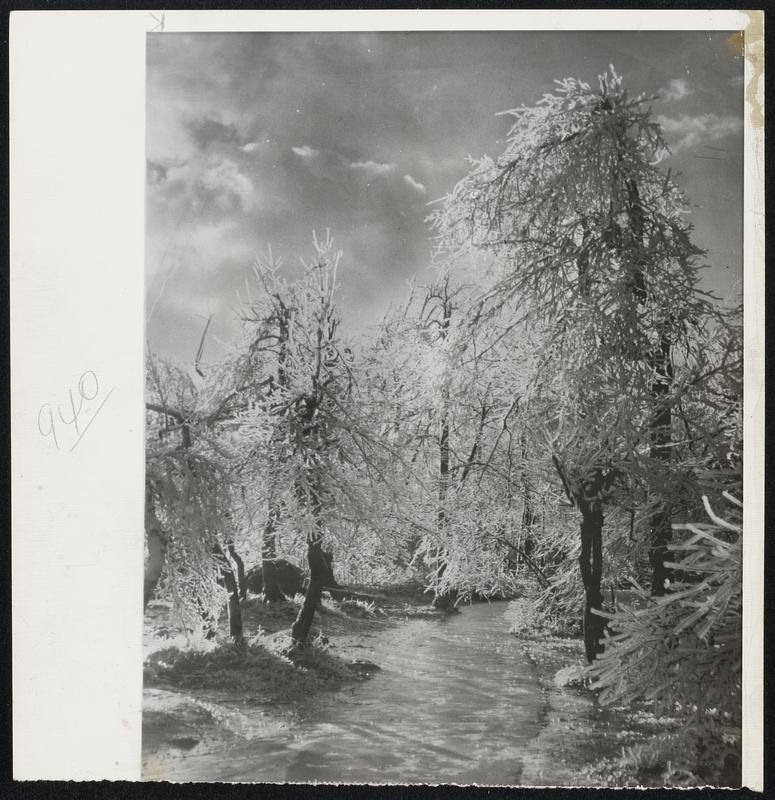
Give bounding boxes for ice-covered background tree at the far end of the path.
[372,275,540,607]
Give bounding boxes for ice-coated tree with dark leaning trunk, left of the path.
[234,235,412,644]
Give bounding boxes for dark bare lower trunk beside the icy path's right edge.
[577,470,606,663]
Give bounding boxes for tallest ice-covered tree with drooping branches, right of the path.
[434,67,732,660]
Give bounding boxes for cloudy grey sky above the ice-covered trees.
[146,32,743,363]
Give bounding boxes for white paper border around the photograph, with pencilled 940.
[9,9,765,790]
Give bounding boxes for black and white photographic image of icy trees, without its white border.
[143,26,743,787]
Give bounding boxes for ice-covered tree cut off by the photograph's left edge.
[143,353,242,641]
